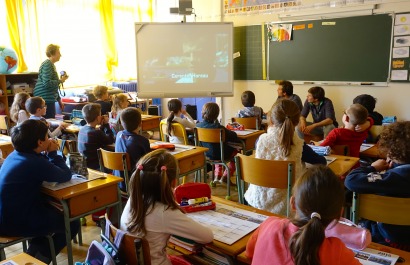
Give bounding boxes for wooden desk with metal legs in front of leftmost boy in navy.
[42,169,123,265]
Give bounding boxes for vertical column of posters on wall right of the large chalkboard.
[390,13,410,82]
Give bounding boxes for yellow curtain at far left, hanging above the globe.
[5,0,27,73]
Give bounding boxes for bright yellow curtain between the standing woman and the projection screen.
[99,0,118,80]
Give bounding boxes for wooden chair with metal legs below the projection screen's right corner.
[194,128,231,200]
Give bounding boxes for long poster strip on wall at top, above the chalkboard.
[224,0,298,15]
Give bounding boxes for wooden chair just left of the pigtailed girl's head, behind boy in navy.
[97,148,131,195]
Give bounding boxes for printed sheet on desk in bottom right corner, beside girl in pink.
[353,248,399,265]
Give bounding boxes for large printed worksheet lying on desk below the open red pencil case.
[187,204,268,245]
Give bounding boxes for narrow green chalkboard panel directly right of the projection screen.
[233,25,266,80]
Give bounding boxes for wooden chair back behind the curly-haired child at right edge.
[352,193,410,225]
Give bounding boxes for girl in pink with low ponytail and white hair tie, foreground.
[246,166,360,265]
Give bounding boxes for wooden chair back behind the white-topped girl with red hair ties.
[101,214,151,265]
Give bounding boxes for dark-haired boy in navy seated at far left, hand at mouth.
[0,120,80,263]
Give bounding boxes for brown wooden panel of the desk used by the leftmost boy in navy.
[68,185,118,217]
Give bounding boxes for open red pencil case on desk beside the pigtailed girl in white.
[174,183,216,213]
